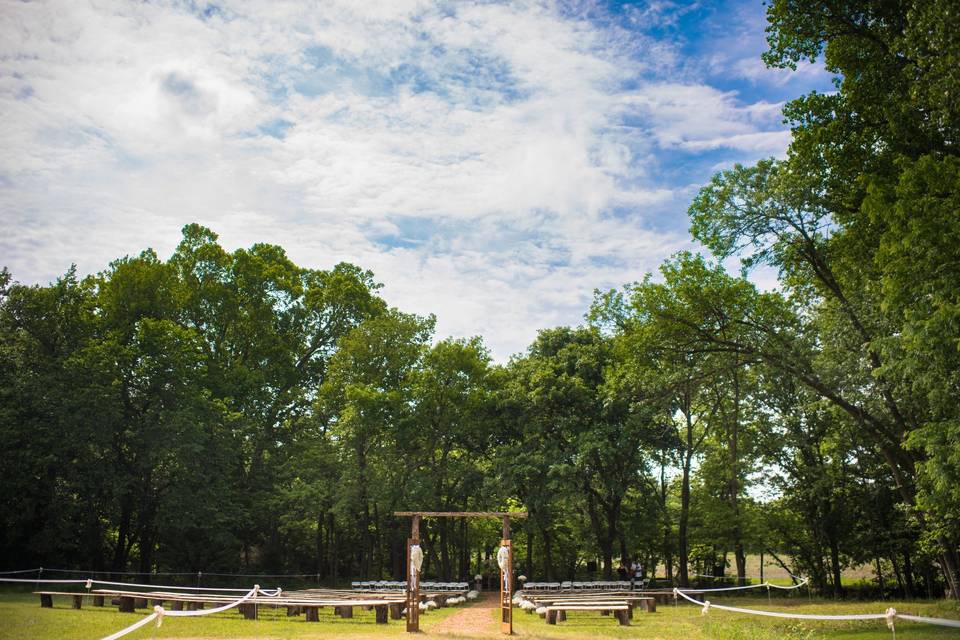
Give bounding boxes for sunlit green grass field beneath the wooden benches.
[0,594,960,640]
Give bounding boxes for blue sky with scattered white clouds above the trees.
[0,0,832,361]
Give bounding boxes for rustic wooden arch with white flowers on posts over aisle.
[393,511,527,635]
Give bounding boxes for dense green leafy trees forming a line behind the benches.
[0,0,960,596]
